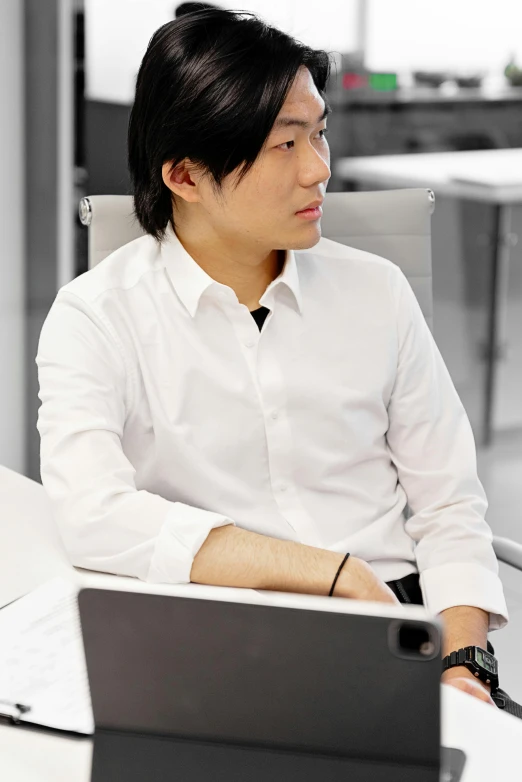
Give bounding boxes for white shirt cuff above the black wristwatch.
[420,562,509,632]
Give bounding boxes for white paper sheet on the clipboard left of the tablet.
[0,577,94,734]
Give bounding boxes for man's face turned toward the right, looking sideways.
[186,67,331,252]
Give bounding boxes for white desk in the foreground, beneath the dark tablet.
[0,466,522,782]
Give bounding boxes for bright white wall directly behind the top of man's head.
[86,0,360,104]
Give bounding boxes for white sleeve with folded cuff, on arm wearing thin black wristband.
[35,291,234,583]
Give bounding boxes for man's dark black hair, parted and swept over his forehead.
[128,9,331,241]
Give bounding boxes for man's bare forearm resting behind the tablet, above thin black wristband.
[190,524,350,595]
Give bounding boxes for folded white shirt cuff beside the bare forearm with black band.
[144,502,235,584]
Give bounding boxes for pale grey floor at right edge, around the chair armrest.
[477,430,522,703]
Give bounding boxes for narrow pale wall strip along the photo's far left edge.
[0,0,26,473]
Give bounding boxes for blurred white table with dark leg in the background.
[335,149,522,445]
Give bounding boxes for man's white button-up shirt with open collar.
[36,220,508,630]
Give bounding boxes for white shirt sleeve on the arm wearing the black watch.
[387,267,509,631]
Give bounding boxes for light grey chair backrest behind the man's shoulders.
[80,188,435,330]
